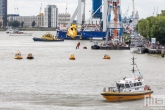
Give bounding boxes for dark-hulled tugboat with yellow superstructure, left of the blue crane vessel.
[33,32,64,42]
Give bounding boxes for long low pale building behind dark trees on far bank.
[8,14,43,27]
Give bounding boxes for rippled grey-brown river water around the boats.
[0,31,165,110]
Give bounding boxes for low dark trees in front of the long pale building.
[8,21,36,27]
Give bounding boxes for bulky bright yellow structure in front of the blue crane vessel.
[67,23,77,39]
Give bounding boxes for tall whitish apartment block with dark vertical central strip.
[44,5,59,28]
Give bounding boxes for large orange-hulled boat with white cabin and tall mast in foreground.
[101,57,153,102]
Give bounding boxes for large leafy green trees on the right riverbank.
[135,10,165,44]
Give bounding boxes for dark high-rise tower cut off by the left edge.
[0,0,7,26]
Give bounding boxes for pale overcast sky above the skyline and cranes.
[8,0,165,19]
